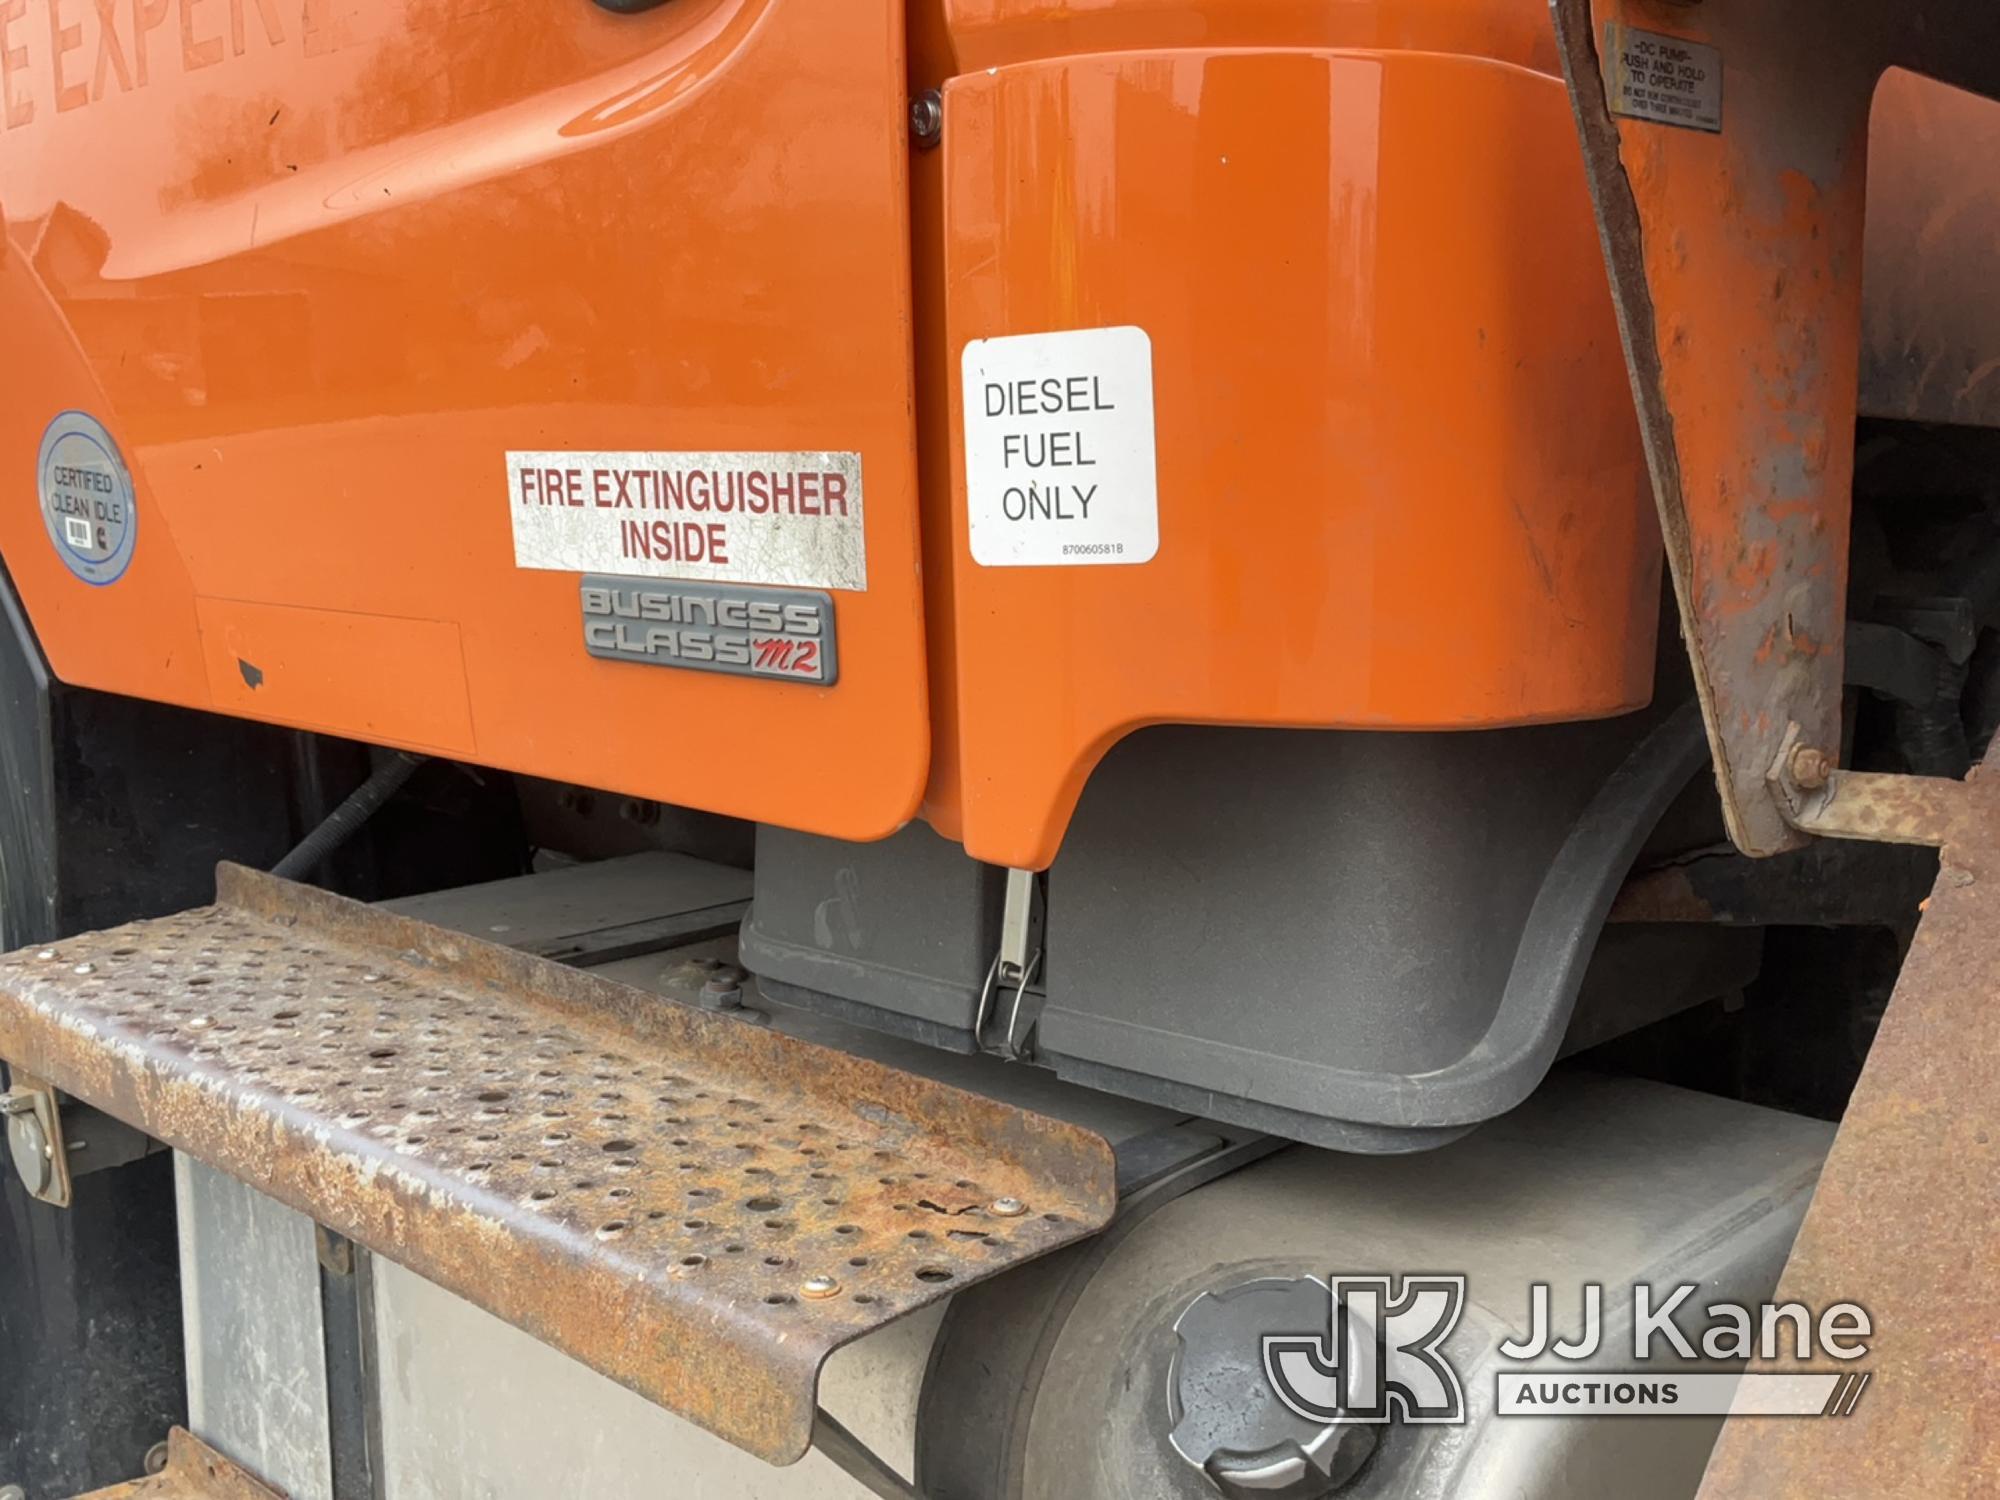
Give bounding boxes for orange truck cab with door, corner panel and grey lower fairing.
[0,0,1680,1138]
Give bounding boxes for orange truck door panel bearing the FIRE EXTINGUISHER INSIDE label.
[0,0,928,838]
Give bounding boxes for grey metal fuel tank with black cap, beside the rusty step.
[916,1072,1832,1500]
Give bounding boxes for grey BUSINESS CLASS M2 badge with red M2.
[582,576,840,688]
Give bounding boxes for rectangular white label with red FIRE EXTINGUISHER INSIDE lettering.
[506,452,868,588]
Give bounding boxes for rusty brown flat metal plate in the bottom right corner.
[1702,752,2000,1500]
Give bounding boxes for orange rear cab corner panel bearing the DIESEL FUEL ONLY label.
[938,20,1660,868]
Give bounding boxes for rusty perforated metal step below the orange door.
[0,866,1116,1462]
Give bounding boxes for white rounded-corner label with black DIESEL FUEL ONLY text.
[960,328,1160,568]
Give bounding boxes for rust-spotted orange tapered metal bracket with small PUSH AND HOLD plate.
[1554,0,2000,854]
